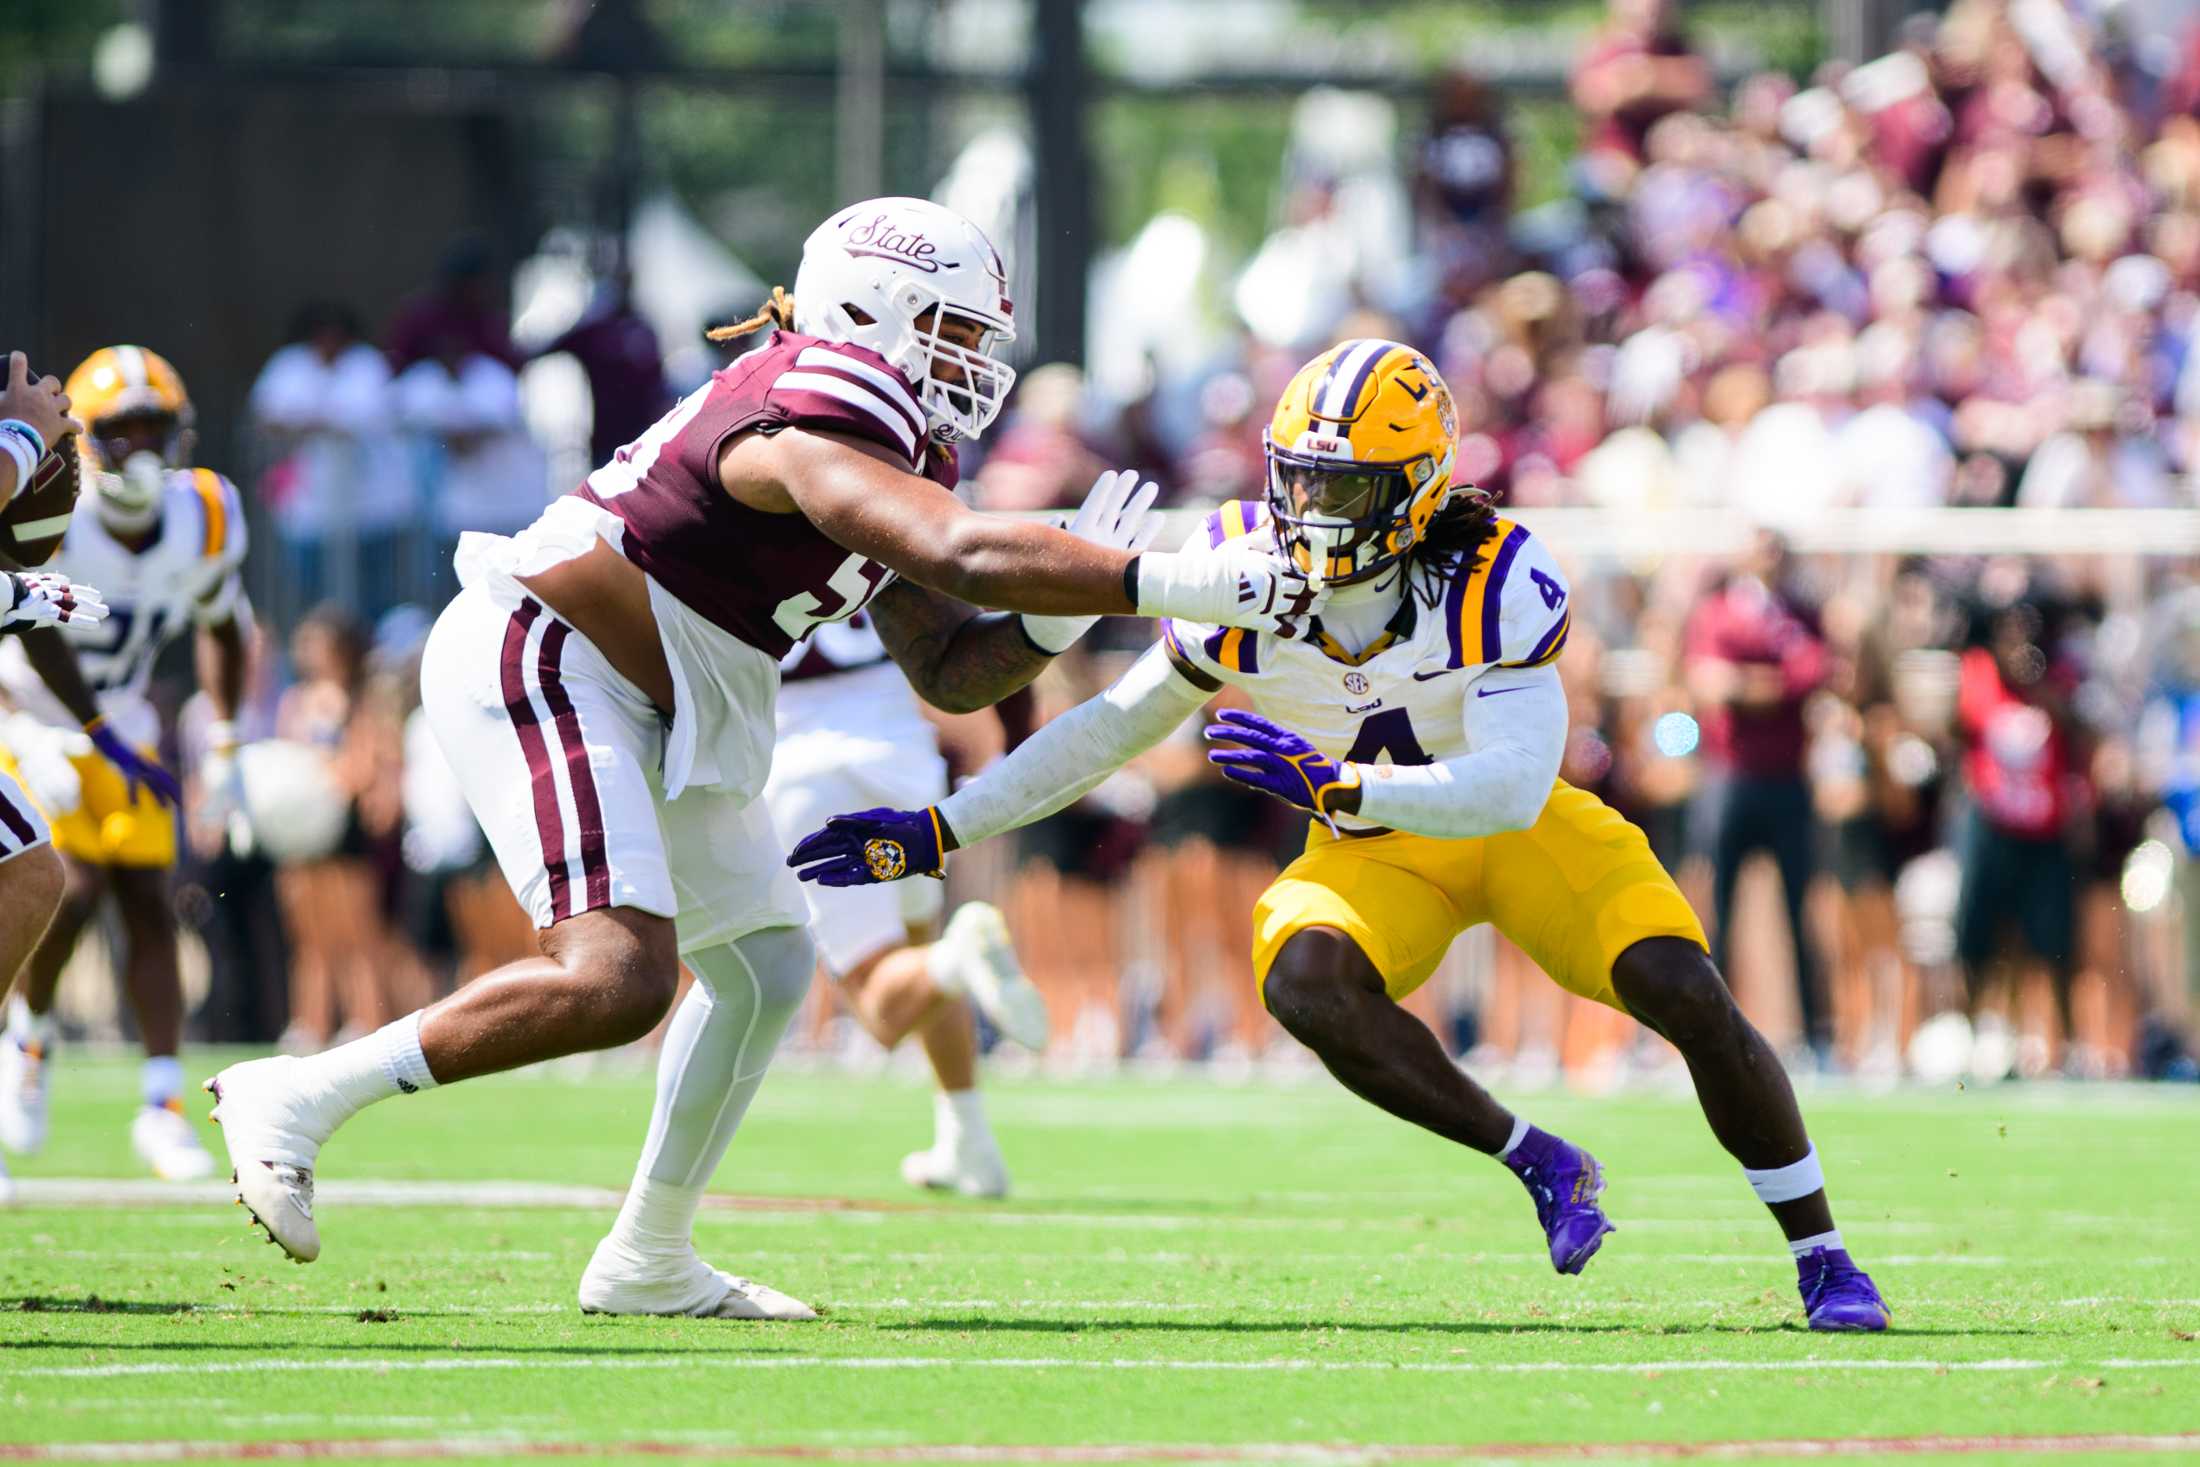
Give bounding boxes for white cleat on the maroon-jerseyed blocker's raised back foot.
[207,1054,337,1262]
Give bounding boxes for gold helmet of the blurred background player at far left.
[64,345,198,530]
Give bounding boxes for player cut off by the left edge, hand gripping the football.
[0,352,106,1203]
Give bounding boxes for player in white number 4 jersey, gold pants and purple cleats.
[790,341,1888,1331]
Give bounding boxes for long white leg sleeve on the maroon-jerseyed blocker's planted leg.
[612,928,816,1254]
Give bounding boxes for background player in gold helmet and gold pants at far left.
[0,345,249,1181]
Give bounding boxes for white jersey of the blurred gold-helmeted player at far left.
[0,468,244,746]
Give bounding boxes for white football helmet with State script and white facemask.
[794,198,1016,442]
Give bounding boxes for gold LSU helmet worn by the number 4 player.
[1263,339,1459,585]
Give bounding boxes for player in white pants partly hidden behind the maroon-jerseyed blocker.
[763,607,1056,1196]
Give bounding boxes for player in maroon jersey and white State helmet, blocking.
[209,198,1322,1320]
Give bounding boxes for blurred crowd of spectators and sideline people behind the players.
[81,0,2200,1078]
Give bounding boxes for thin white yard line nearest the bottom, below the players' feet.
[17,1355,2200,1381]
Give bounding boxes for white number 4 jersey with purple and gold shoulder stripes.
[1162,499,1571,827]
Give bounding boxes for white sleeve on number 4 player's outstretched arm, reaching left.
[939,647,1208,845]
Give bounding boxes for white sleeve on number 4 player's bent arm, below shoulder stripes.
[1353,666,1566,840]
